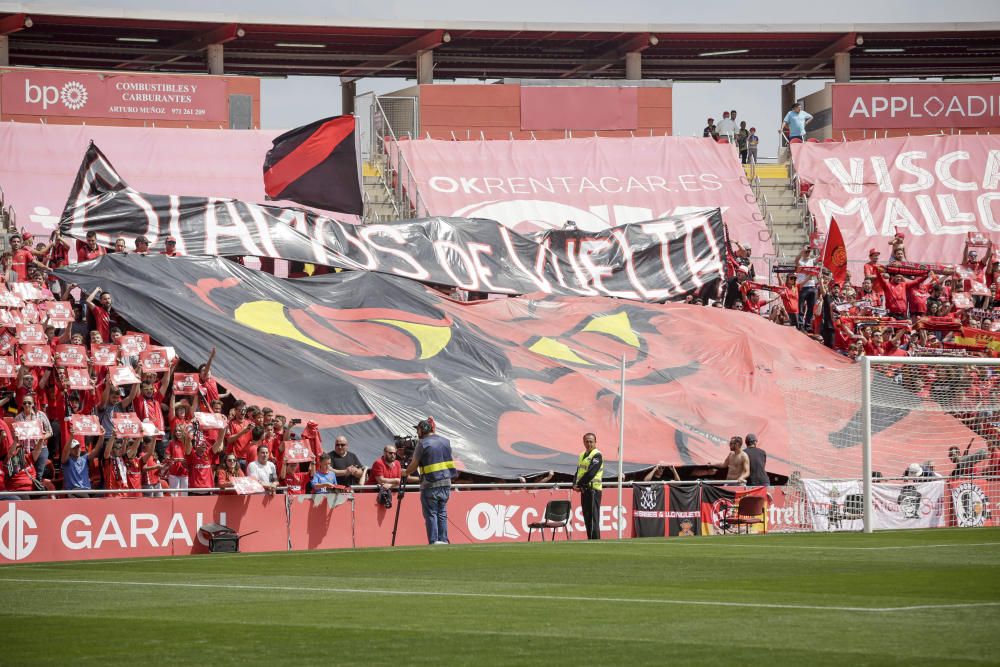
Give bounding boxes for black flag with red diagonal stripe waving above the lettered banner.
[264,116,363,215]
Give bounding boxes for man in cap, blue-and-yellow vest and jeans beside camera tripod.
[406,417,458,544]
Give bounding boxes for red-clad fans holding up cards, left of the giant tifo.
[0,233,422,499]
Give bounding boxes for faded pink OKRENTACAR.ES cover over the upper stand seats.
[400,137,772,254]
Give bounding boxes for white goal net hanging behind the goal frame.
[782,357,1000,530]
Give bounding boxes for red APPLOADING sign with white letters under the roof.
[833,83,1000,131]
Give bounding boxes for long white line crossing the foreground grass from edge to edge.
[0,577,1000,612]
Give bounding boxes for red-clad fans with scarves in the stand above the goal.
[716,233,1000,359]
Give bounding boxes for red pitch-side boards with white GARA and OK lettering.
[0,489,632,563]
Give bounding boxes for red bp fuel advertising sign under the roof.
[0,70,229,121]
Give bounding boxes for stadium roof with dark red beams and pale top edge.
[0,0,1000,80]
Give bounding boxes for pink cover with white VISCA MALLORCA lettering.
[792,136,1000,263]
